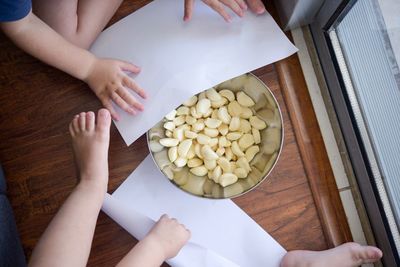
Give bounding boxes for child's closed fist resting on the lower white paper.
[147,214,190,260]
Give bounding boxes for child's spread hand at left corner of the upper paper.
[84,58,146,120]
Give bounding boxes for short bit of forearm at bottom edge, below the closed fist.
[117,236,165,267]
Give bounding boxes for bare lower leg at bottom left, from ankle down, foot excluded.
[29,181,106,267]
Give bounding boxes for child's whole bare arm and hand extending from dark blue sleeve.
[0,11,146,119]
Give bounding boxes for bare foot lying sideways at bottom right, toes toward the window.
[281,242,382,267]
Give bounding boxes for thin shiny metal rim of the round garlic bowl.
[146,72,285,200]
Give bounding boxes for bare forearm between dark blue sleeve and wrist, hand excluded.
[1,12,96,80]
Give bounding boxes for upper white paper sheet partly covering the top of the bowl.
[91,0,297,145]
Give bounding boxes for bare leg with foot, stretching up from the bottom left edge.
[30,109,111,266]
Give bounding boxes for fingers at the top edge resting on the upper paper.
[183,0,265,22]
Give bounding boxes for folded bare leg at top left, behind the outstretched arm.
[33,0,122,49]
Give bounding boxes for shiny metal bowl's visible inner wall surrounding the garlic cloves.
[147,74,284,199]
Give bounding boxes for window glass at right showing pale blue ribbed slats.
[329,0,400,230]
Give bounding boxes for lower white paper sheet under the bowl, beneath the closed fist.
[103,156,286,267]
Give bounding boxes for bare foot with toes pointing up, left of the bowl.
[69,109,111,190]
